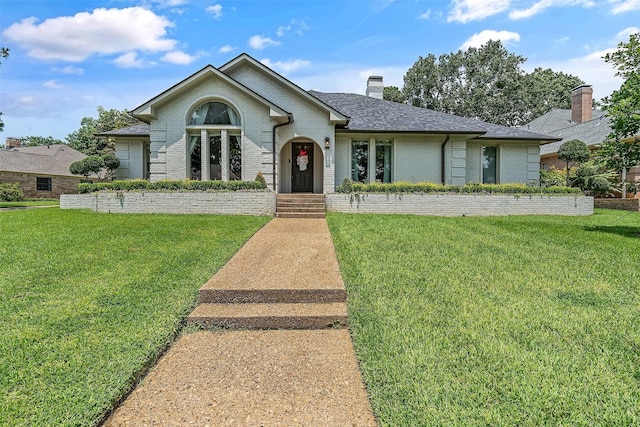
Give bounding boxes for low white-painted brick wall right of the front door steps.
[325,193,593,216]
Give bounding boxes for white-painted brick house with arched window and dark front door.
[102,54,558,193]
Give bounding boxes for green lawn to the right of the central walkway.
[327,210,640,426]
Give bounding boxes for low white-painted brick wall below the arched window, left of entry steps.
[60,191,276,215]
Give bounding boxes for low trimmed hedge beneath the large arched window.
[78,179,266,194]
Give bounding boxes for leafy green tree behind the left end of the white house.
[66,107,142,156]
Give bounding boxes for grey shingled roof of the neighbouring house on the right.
[522,108,611,156]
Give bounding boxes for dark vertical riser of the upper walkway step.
[199,287,347,304]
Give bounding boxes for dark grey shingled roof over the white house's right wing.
[309,91,557,141]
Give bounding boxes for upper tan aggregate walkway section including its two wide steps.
[187,218,348,329]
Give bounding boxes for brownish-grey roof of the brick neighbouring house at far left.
[0,144,87,177]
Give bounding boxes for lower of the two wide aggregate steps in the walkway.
[187,303,347,329]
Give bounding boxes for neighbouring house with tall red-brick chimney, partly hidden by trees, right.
[522,85,640,197]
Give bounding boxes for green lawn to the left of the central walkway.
[0,208,268,426]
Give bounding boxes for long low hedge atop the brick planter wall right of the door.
[336,181,581,194]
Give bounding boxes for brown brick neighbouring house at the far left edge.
[0,138,87,198]
